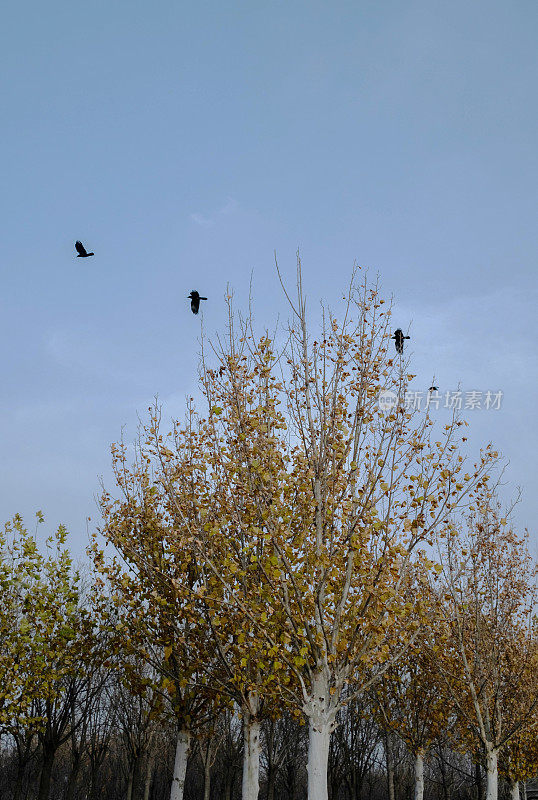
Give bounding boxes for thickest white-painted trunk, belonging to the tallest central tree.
[303,670,336,800]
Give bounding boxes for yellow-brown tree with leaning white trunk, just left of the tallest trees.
[90,462,225,800]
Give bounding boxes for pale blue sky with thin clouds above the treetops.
[0,0,538,553]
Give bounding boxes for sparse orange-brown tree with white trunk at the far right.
[432,494,538,800]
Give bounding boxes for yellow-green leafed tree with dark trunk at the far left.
[0,512,108,800]
